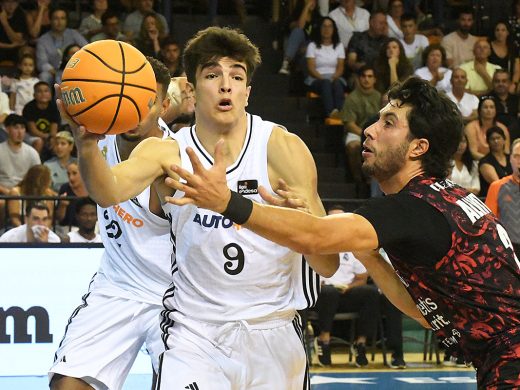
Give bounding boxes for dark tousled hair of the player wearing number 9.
[183,27,262,85]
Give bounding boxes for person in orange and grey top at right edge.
[486,139,520,257]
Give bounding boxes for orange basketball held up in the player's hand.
[61,40,156,134]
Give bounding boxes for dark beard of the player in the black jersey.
[361,141,410,183]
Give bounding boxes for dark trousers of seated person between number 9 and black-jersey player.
[316,284,380,339]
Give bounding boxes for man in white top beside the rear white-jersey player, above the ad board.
[62,197,102,243]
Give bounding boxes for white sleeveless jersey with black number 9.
[163,114,319,322]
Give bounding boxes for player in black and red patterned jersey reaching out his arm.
[166,77,520,389]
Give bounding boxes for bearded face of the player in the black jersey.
[362,100,411,182]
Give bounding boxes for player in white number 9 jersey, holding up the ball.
[58,27,339,390]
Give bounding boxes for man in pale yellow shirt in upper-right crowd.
[460,39,500,96]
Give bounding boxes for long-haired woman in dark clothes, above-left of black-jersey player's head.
[374,38,413,93]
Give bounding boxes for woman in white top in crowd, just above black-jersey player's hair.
[415,44,451,93]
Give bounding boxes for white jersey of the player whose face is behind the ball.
[97,122,173,305]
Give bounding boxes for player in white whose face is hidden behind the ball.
[49,58,171,390]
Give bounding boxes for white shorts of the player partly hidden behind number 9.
[49,291,164,390]
